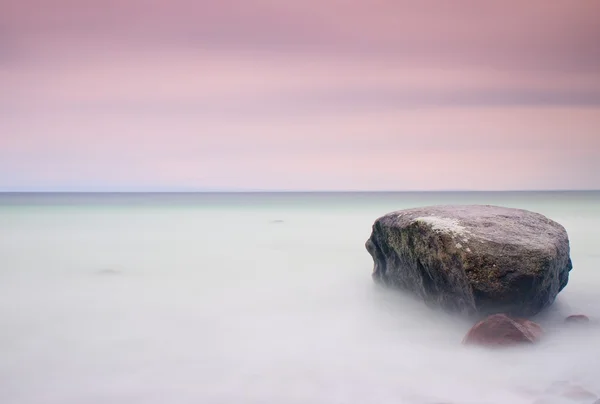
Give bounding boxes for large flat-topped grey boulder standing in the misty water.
[366,205,572,317]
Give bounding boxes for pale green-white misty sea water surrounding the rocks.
[0,192,600,404]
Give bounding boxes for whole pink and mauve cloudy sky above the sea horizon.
[0,0,600,191]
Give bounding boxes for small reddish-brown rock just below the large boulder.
[463,314,543,346]
